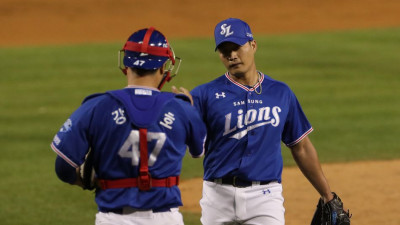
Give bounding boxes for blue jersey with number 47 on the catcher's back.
[51,86,206,211]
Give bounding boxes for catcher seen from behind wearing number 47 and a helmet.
[51,27,206,225]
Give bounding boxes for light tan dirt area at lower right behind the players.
[180,160,400,225]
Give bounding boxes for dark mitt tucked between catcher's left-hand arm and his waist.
[79,149,96,190]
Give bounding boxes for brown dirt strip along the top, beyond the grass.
[0,0,400,46]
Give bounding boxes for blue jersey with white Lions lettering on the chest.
[191,72,312,182]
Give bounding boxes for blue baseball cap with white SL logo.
[214,18,253,51]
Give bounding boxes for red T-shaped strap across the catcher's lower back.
[98,128,179,191]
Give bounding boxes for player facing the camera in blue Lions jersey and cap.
[191,18,344,225]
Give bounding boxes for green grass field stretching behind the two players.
[0,28,400,225]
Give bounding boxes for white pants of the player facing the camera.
[200,181,285,225]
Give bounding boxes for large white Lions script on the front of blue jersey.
[223,106,282,140]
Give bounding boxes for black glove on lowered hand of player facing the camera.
[311,192,351,225]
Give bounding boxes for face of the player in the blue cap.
[218,41,256,76]
